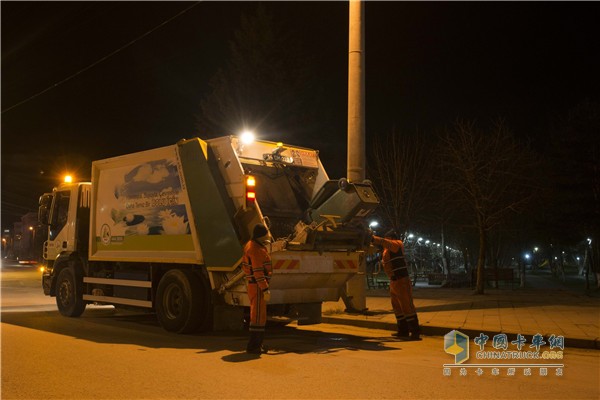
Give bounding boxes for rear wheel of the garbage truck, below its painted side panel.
[155,269,208,333]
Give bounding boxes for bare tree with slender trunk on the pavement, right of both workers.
[441,120,536,294]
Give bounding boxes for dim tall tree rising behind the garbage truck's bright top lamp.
[196,3,329,141]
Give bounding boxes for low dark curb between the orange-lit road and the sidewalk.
[321,315,600,350]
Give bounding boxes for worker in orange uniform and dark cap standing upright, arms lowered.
[242,224,273,354]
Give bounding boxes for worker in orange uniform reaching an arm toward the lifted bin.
[373,230,421,340]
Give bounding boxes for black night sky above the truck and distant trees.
[1,1,600,229]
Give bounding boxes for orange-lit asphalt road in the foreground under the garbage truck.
[1,258,600,400]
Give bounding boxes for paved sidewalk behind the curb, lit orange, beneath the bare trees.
[323,271,600,349]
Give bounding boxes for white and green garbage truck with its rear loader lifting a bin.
[38,136,379,333]
